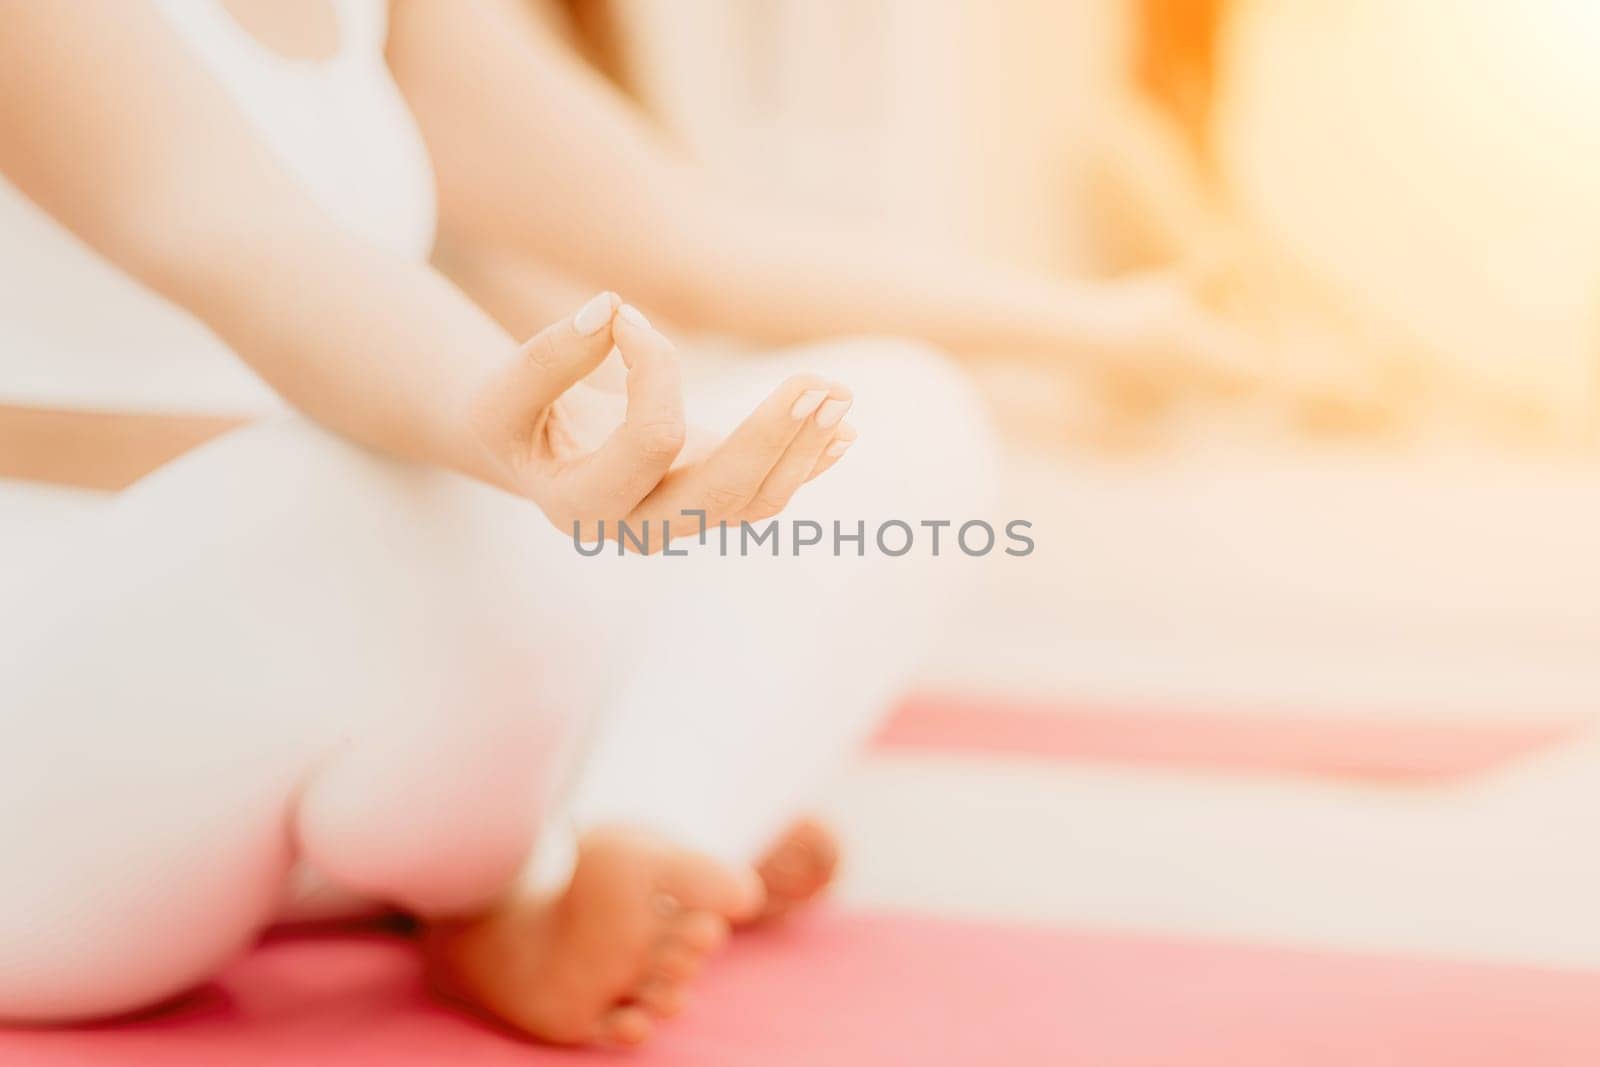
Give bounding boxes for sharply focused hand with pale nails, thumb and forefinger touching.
[469,293,856,550]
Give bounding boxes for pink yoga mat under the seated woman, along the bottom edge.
[0,913,1600,1067]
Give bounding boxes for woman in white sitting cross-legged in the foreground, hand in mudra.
[0,0,1299,1043]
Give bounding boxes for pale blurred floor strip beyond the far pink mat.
[930,453,1600,718]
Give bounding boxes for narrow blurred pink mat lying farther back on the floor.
[877,696,1584,782]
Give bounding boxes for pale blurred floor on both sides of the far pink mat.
[830,444,1600,968]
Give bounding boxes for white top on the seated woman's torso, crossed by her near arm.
[0,0,435,414]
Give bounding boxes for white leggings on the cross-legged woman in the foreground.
[0,341,992,1021]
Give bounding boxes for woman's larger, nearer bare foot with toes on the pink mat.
[426,830,762,1045]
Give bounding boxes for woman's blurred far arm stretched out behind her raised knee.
[389,0,1261,406]
